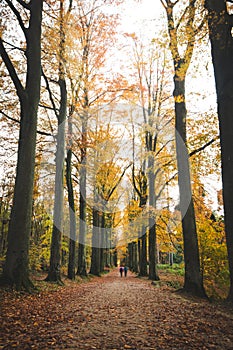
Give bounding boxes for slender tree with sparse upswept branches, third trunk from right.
[126,34,174,280]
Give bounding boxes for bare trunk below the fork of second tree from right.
[174,75,206,297]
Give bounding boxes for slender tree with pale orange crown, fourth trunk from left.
[63,0,122,276]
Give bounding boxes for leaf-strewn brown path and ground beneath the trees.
[0,270,233,350]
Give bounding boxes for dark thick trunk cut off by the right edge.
[206,0,233,302]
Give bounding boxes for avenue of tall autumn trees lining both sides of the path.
[0,0,233,301]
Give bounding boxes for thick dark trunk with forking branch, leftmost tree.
[0,0,43,290]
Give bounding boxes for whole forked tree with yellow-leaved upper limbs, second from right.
[161,0,205,297]
